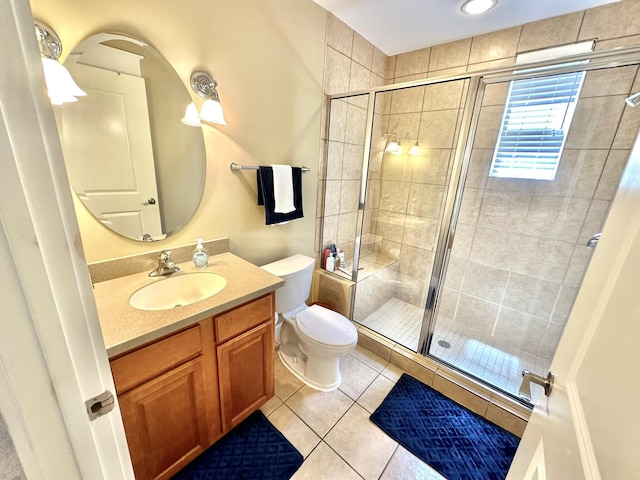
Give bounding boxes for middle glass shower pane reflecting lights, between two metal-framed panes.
[353,78,469,351]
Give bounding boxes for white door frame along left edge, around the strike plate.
[0,0,134,480]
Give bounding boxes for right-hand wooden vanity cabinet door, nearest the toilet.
[218,321,274,431]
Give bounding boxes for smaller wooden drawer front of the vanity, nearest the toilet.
[215,293,274,344]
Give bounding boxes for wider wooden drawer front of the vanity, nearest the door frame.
[111,324,202,394]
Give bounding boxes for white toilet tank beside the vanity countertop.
[260,254,315,313]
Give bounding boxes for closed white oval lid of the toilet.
[296,305,358,347]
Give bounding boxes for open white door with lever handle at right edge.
[507,132,640,480]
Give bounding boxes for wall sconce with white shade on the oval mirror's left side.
[34,20,86,105]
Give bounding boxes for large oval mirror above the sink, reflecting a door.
[55,33,206,241]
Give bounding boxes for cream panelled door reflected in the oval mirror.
[56,63,163,239]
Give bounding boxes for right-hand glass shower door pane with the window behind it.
[426,65,638,396]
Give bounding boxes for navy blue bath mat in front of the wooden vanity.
[172,410,304,480]
